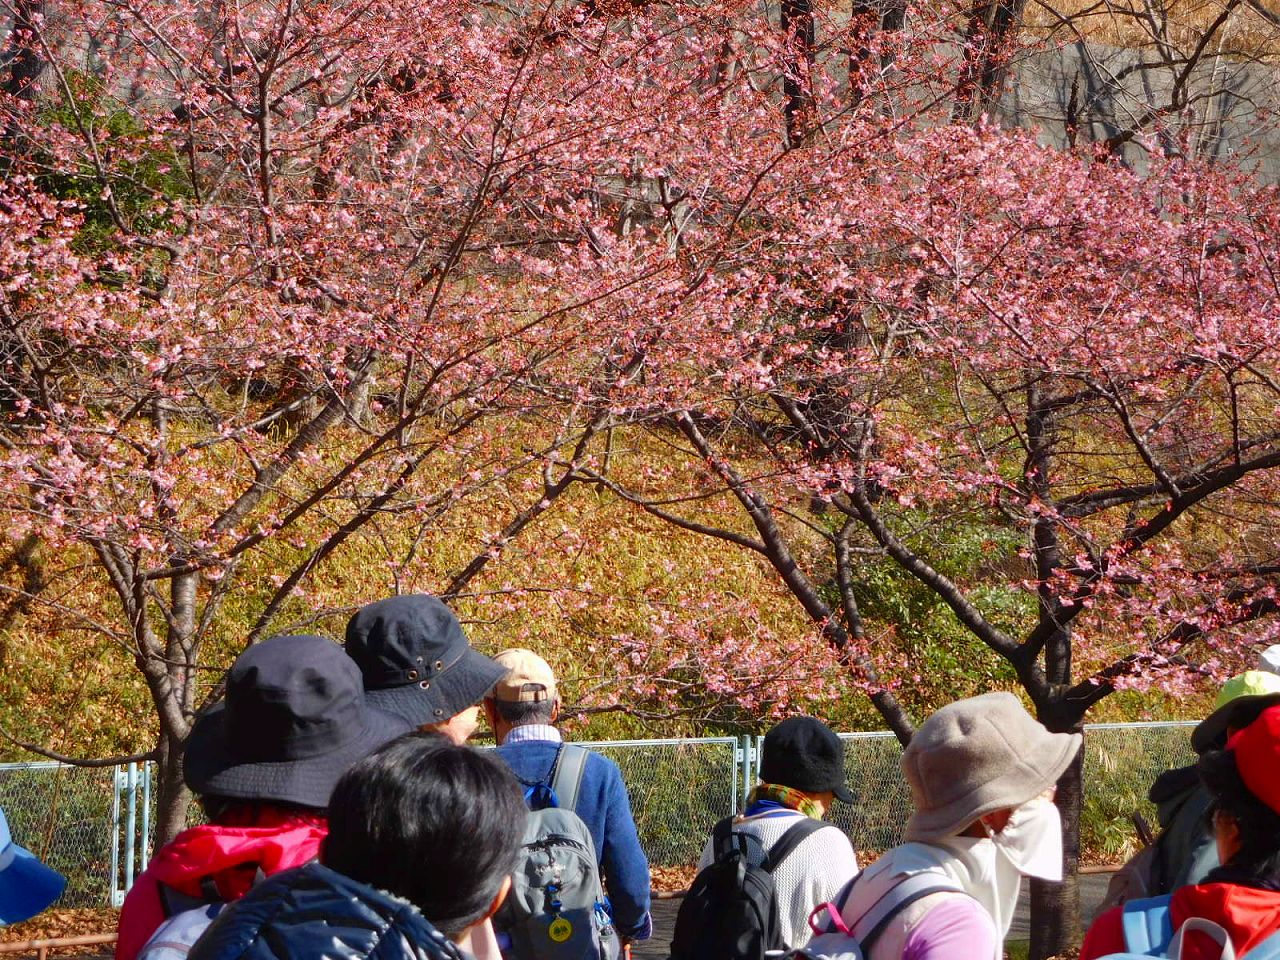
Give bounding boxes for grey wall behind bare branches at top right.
[993,41,1280,183]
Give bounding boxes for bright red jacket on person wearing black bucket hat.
[115,809,328,960]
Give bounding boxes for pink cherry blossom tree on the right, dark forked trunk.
[585,127,1280,956]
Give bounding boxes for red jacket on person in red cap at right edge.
[1080,883,1280,960]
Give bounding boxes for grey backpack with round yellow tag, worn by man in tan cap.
[494,744,621,960]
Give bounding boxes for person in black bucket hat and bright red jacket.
[115,636,408,960]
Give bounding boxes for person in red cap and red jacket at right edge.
[1080,705,1280,960]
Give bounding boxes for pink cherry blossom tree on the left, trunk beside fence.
[0,0,732,840]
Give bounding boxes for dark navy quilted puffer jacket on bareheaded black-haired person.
[189,863,467,960]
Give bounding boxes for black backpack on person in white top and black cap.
[669,817,827,960]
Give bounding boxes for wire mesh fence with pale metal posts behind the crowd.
[0,722,1196,906]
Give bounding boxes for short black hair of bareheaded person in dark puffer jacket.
[320,732,526,937]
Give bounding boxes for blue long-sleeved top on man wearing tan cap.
[498,740,652,940]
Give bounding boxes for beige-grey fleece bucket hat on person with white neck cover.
[902,692,1083,841]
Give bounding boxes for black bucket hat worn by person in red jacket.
[183,636,408,808]
